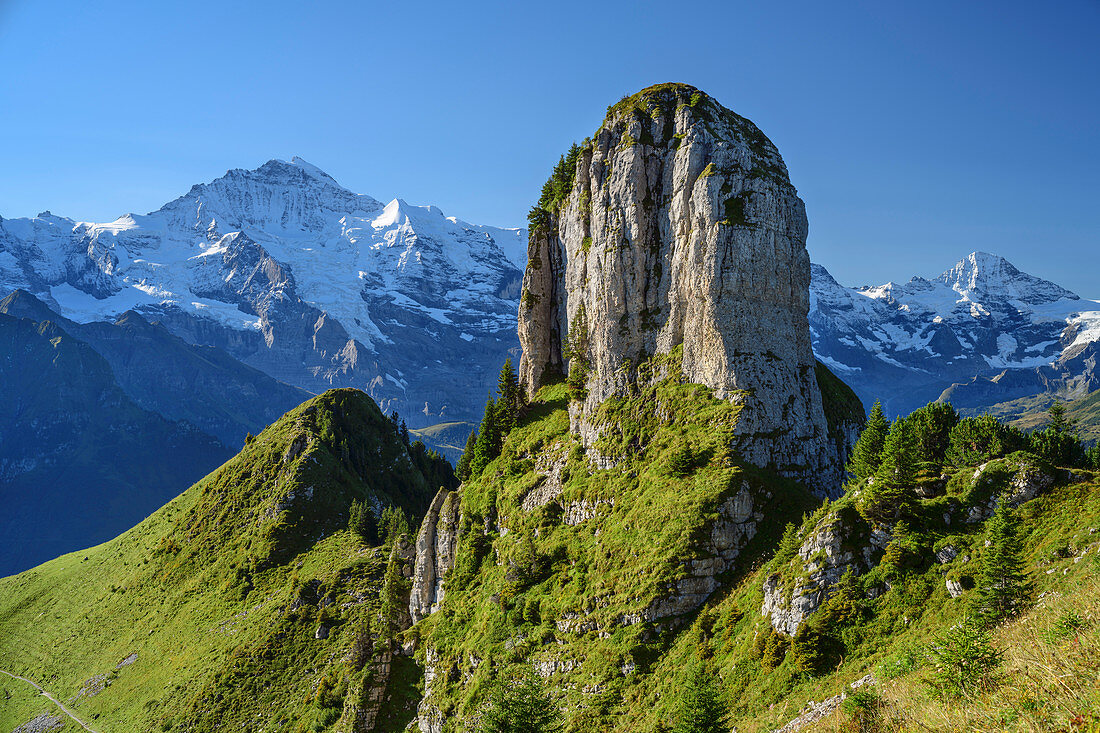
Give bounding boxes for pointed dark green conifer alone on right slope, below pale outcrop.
[971,497,1031,626]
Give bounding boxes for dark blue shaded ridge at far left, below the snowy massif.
[0,291,309,576]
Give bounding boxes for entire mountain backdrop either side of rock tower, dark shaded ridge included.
[0,158,1100,575]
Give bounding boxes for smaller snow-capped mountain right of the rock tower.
[810,252,1100,414]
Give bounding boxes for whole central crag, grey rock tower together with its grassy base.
[407,85,864,733]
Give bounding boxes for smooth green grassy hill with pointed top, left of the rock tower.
[0,390,452,732]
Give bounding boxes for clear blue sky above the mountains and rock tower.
[0,0,1100,298]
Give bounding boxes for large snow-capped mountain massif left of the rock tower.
[0,158,527,425]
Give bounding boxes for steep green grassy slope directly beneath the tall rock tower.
[410,352,862,731]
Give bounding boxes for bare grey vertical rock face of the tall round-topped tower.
[519,85,836,477]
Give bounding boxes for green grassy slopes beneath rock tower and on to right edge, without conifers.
[409,352,1100,733]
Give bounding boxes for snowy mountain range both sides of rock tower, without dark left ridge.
[0,157,1100,427]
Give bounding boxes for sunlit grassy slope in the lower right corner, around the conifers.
[651,459,1100,732]
